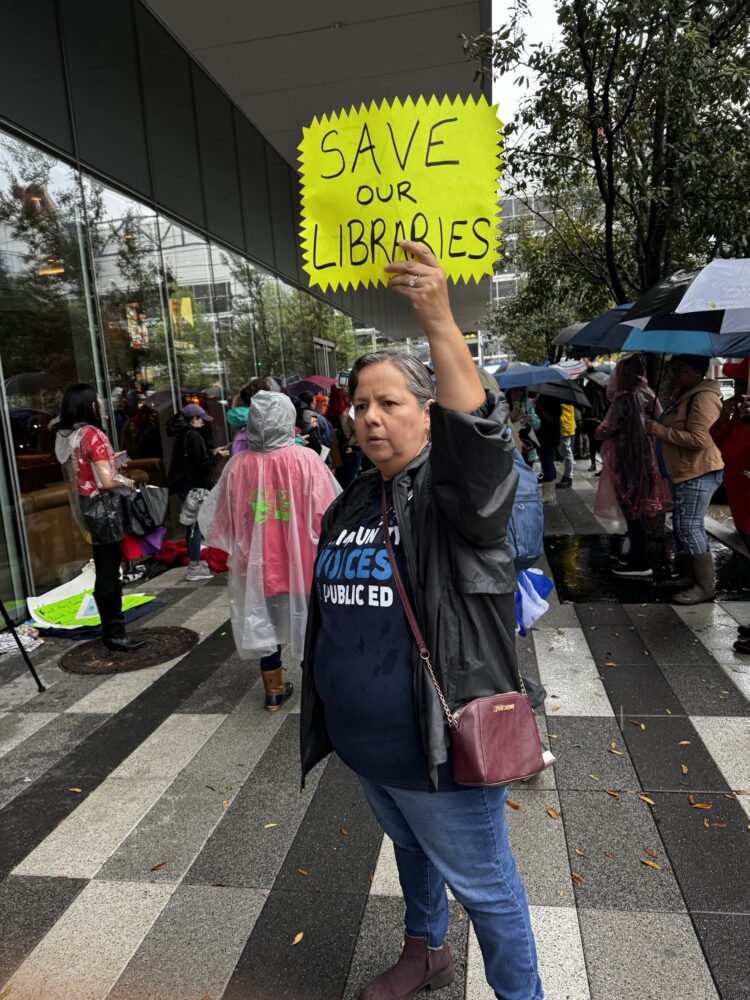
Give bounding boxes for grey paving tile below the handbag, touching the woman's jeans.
[505,788,575,907]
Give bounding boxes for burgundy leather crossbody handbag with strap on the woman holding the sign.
[380,480,554,785]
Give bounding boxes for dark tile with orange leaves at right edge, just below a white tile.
[649,792,750,913]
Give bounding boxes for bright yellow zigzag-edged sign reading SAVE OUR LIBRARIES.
[299,97,502,291]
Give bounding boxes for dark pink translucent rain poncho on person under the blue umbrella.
[594,354,670,521]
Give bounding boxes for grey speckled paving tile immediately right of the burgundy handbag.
[547,715,640,791]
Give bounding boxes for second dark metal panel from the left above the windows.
[60,0,153,198]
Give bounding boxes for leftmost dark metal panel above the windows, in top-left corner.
[0,0,75,154]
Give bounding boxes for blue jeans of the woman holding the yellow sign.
[359,776,544,1000]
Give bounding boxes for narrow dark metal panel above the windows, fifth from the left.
[234,109,276,268]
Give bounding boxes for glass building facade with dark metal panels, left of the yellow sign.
[0,0,412,618]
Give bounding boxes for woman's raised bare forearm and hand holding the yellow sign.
[385,240,485,413]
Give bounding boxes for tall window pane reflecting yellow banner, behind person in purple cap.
[159,216,229,445]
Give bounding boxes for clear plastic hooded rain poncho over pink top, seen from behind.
[198,391,341,660]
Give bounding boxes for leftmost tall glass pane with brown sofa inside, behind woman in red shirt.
[0,133,101,591]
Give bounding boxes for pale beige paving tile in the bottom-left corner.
[0,882,172,1000]
